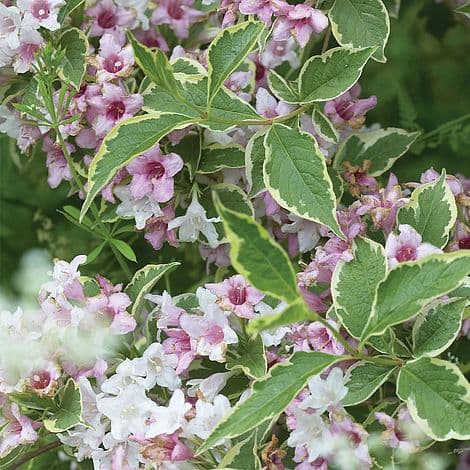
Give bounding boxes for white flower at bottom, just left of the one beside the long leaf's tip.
[145,389,192,437]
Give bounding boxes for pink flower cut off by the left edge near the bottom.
[0,394,41,458]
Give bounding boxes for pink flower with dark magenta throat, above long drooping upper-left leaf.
[87,83,144,137]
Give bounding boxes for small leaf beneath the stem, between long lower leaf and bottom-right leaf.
[341,361,396,406]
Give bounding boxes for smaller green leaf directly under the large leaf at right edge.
[413,299,466,357]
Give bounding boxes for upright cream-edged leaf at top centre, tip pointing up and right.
[207,21,264,108]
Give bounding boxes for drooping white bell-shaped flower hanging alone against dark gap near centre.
[168,192,220,248]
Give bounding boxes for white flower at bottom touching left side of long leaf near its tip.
[185,395,230,439]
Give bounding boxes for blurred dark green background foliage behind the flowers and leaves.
[0,0,470,294]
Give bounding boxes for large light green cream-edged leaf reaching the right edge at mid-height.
[362,250,470,339]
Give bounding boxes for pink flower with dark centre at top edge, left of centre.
[86,0,135,36]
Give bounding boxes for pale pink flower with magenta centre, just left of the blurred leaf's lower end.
[206,274,264,318]
